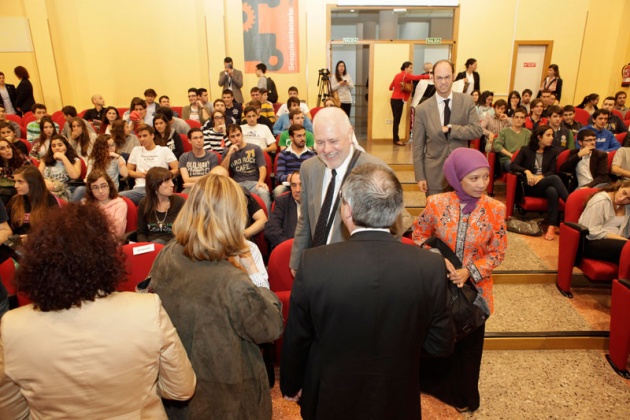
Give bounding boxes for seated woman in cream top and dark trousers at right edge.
[578,181,630,264]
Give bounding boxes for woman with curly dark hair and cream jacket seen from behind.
[0,203,196,419]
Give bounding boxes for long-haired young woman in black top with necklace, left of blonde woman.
[137,166,186,245]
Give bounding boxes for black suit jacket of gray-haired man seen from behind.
[280,231,454,420]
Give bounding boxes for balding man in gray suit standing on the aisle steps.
[413,60,483,196]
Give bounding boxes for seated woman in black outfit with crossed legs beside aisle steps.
[510,125,569,241]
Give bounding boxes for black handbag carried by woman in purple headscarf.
[423,236,490,341]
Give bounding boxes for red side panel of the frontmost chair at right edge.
[606,278,630,379]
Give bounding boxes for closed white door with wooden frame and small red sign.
[510,41,553,97]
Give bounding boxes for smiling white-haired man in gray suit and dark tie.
[289,107,396,274]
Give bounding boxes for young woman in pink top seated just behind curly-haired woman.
[85,169,127,241]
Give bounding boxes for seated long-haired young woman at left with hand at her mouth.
[39,136,81,201]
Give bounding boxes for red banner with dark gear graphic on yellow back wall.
[243,0,300,73]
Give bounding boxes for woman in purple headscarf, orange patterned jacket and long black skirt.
[413,148,507,412]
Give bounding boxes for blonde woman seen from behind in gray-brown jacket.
[151,174,283,419]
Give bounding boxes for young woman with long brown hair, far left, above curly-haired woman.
[7,166,59,235]
